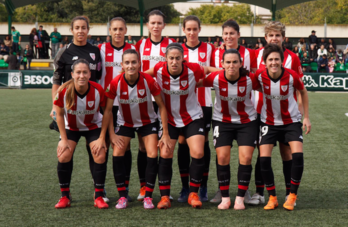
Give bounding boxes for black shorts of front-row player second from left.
[115,121,158,138]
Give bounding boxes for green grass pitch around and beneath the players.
[0,90,348,226]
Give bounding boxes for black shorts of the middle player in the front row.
[168,118,205,140]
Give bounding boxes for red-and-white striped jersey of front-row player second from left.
[106,72,161,128]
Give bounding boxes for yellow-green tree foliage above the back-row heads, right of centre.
[186,4,260,24]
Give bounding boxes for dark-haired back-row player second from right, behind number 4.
[210,19,256,203]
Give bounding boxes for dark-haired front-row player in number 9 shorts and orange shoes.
[253,44,311,210]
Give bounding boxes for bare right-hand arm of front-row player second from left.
[154,94,172,152]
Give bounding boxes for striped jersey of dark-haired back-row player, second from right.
[212,46,256,71]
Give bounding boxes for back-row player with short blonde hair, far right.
[249,21,303,205]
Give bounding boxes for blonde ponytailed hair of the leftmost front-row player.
[57,59,90,110]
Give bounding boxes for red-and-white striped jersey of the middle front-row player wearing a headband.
[154,62,205,128]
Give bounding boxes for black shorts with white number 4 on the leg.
[213,120,259,148]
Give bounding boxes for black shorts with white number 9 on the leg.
[260,122,303,145]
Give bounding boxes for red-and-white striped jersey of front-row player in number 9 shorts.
[252,68,304,125]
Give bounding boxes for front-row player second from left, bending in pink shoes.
[98,49,170,209]
